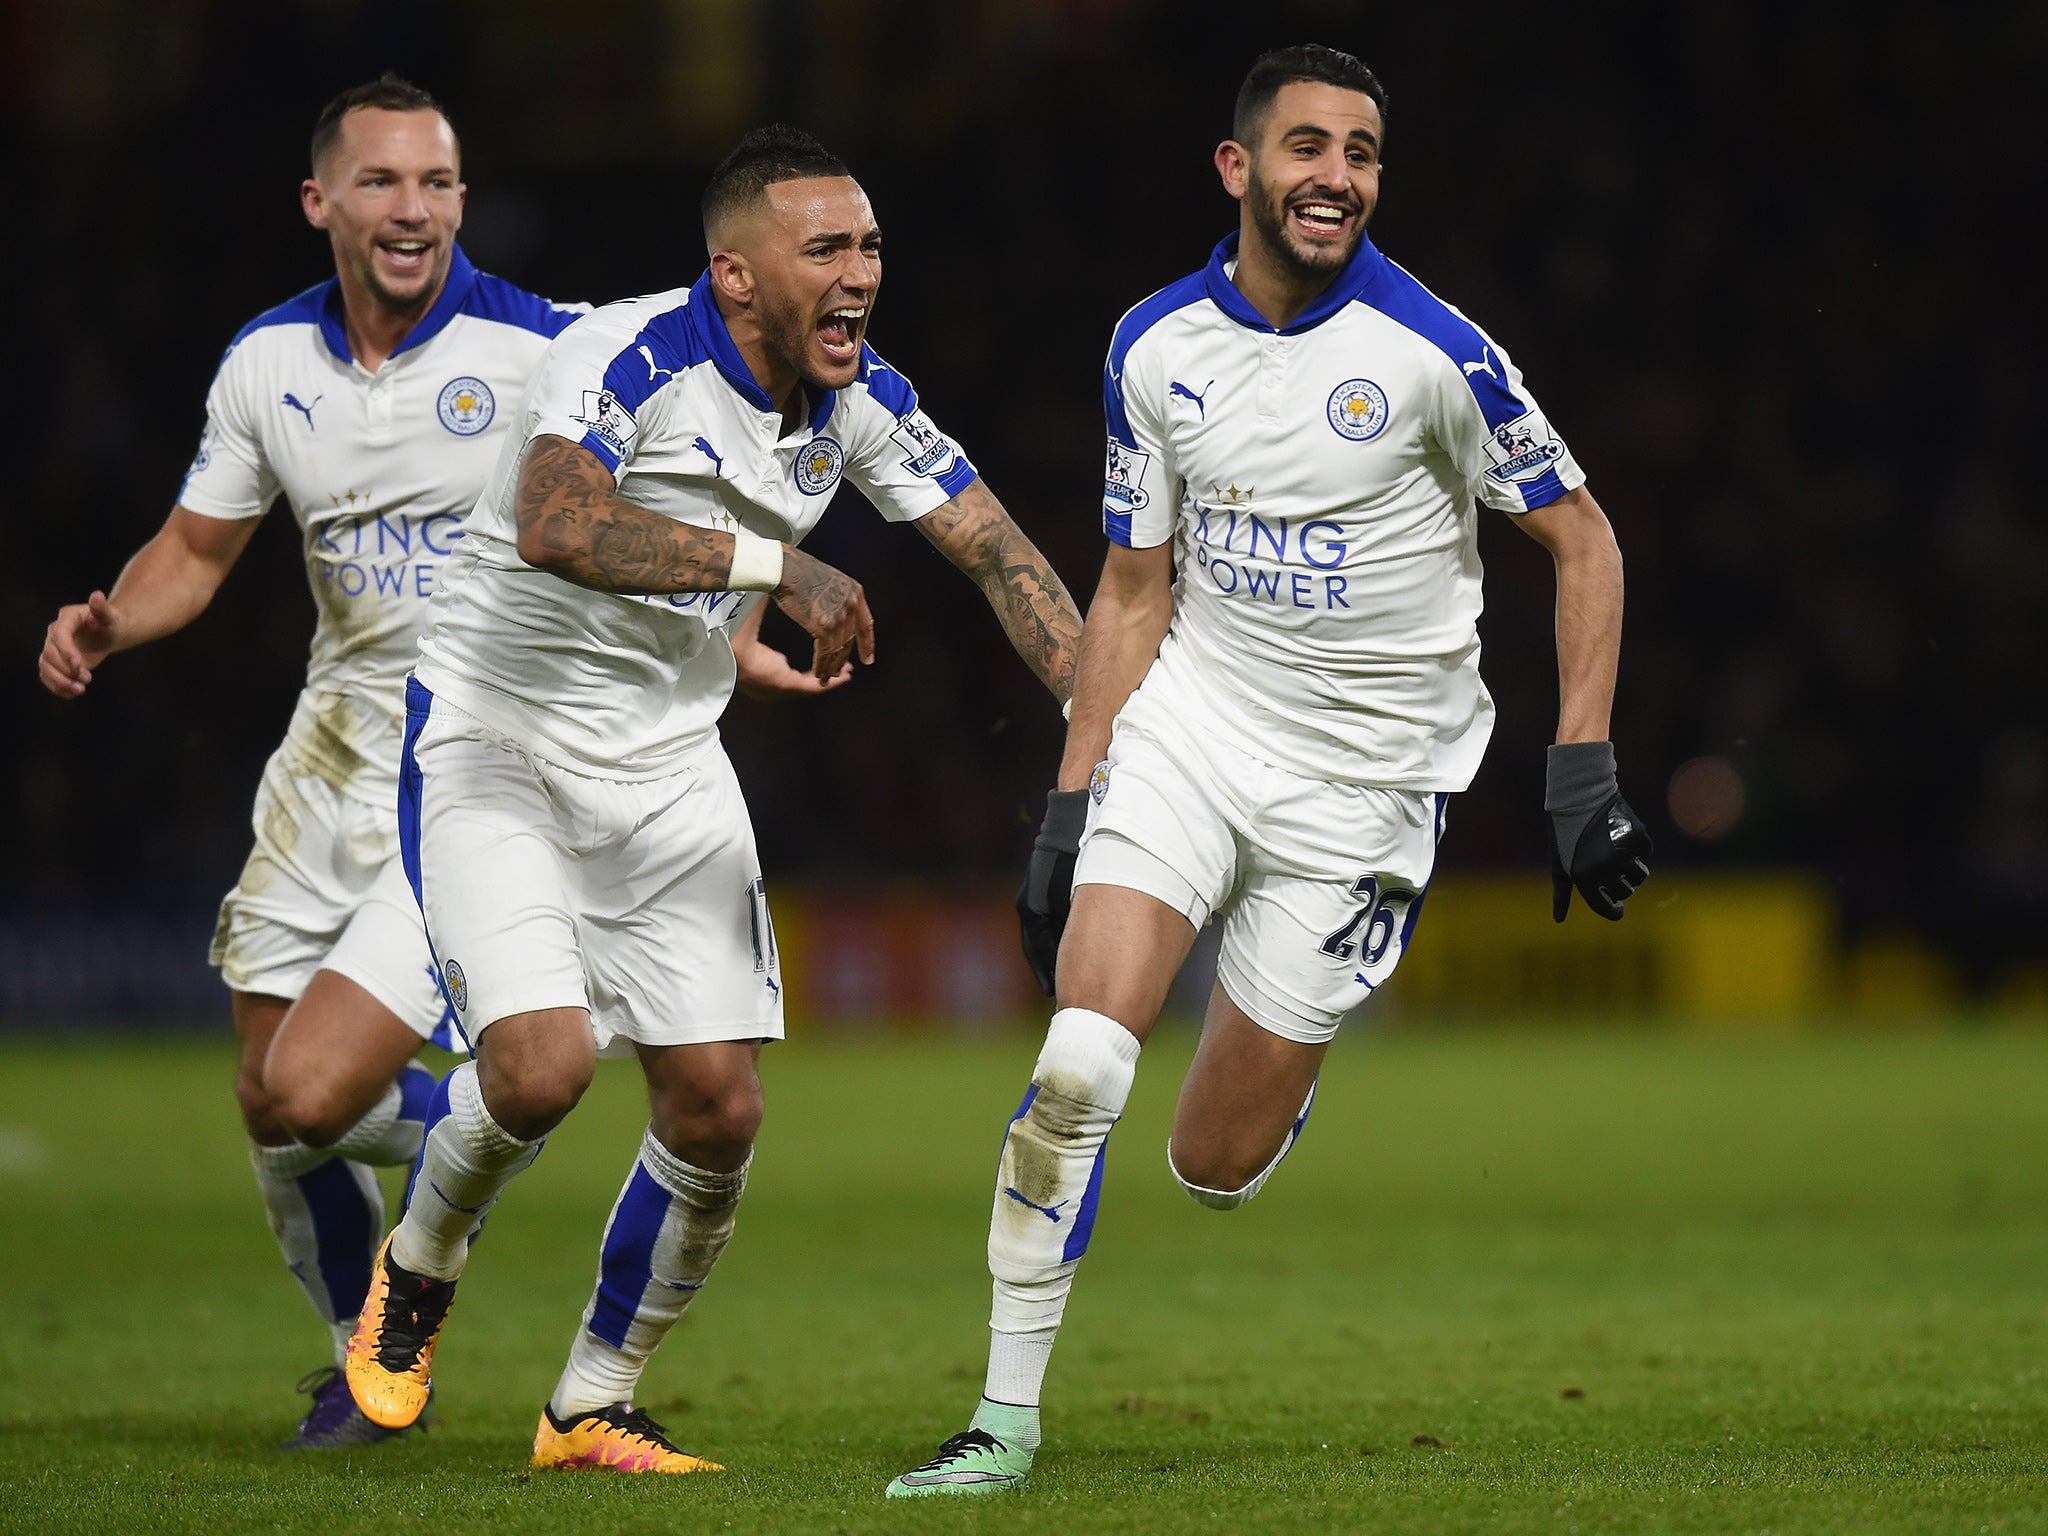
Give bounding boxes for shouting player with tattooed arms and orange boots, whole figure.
[348,129,1079,1473]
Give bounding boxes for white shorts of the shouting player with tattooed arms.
[399,680,782,1055]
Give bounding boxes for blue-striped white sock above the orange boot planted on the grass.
[549,1126,754,1419]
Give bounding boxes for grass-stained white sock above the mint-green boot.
[983,1008,1139,1407]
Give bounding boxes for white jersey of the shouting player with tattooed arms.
[418,274,975,778]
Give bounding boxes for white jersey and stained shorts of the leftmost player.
[178,248,588,1047]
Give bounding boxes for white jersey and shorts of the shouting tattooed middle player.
[401,276,975,1053]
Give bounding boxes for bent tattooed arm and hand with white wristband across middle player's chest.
[514,434,874,682]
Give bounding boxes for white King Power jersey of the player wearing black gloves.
[1104,236,1585,791]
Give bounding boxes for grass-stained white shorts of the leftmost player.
[209,748,467,1051]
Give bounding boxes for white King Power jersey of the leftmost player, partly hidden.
[178,248,590,807]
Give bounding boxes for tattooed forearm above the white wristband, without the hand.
[514,436,733,594]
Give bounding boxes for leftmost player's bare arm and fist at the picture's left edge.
[37,506,258,698]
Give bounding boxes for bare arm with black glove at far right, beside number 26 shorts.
[1518,485,1653,922]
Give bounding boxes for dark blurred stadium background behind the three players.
[0,0,2048,1028]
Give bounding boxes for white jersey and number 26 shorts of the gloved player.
[1075,236,1585,1042]
